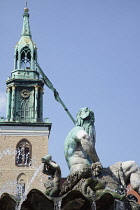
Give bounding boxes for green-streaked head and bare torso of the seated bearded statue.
[64,107,99,173]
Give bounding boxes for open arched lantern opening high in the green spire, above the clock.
[20,46,31,69]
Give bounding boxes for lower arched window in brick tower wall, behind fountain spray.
[17,173,26,197]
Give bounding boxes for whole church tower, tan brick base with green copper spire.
[0,5,51,197]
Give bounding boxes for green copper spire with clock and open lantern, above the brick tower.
[6,3,44,123]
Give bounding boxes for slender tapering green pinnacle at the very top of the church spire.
[22,2,31,36]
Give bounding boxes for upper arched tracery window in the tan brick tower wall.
[15,139,32,166]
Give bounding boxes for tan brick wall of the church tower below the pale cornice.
[0,126,48,199]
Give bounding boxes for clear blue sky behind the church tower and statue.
[0,0,140,176]
